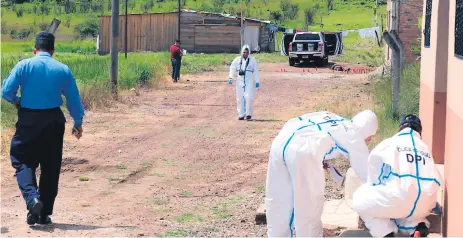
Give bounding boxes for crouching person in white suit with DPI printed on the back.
[353,115,440,237]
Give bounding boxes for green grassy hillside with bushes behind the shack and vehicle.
[1,0,386,41]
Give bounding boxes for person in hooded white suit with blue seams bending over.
[265,110,378,237]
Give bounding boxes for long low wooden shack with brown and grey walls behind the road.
[98,10,275,54]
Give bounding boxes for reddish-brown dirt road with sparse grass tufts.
[1,64,376,236]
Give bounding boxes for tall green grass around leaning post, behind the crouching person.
[373,64,420,139]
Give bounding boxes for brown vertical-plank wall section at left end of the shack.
[98,13,178,54]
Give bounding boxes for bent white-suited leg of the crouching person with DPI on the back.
[353,184,407,237]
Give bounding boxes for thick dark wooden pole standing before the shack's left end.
[109,0,119,98]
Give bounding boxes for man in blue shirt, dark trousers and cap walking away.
[2,32,85,225]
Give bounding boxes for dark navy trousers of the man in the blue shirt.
[10,108,66,216]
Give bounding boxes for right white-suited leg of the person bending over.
[287,153,325,237]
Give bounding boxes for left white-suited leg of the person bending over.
[265,143,293,237]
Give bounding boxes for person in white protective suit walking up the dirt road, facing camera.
[228,45,260,120]
